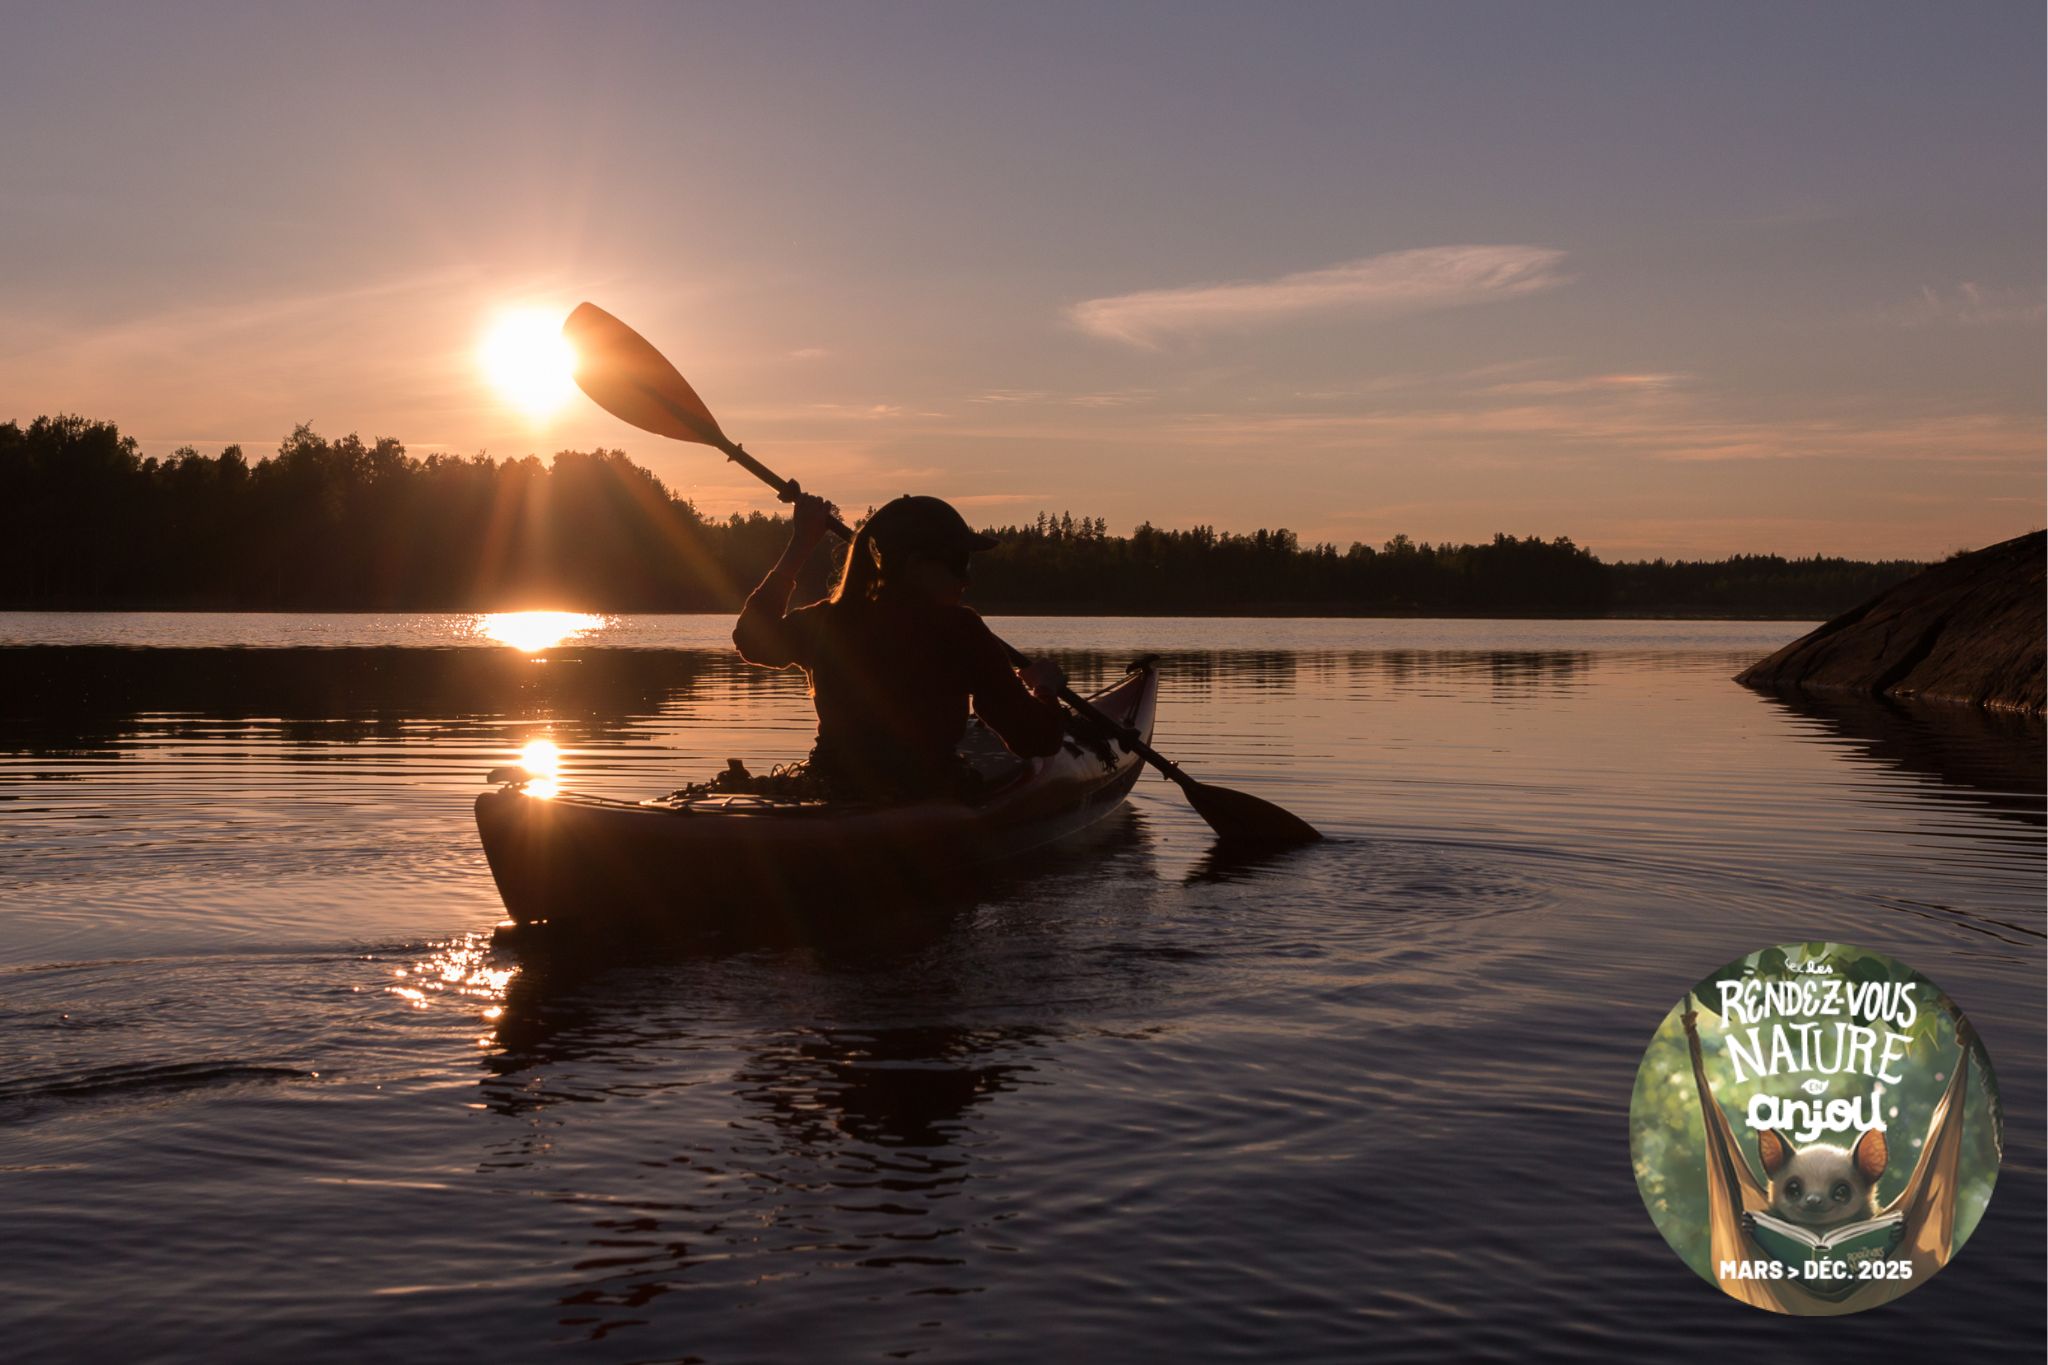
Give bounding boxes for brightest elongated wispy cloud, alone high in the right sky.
[1067,246,1567,346]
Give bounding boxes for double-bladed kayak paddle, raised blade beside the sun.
[561,303,1323,847]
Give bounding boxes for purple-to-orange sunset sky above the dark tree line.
[0,0,2044,559]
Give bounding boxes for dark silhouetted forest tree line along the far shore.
[0,415,1921,618]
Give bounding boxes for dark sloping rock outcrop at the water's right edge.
[1735,532,2048,716]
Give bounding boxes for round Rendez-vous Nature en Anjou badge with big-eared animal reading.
[1628,943,2003,1314]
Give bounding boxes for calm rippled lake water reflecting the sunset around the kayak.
[0,616,2044,1363]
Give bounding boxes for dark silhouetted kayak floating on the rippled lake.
[477,659,1159,929]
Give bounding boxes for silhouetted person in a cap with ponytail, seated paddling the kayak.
[733,491,1067,800]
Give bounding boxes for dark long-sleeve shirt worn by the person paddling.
[733,575,1065,794]
